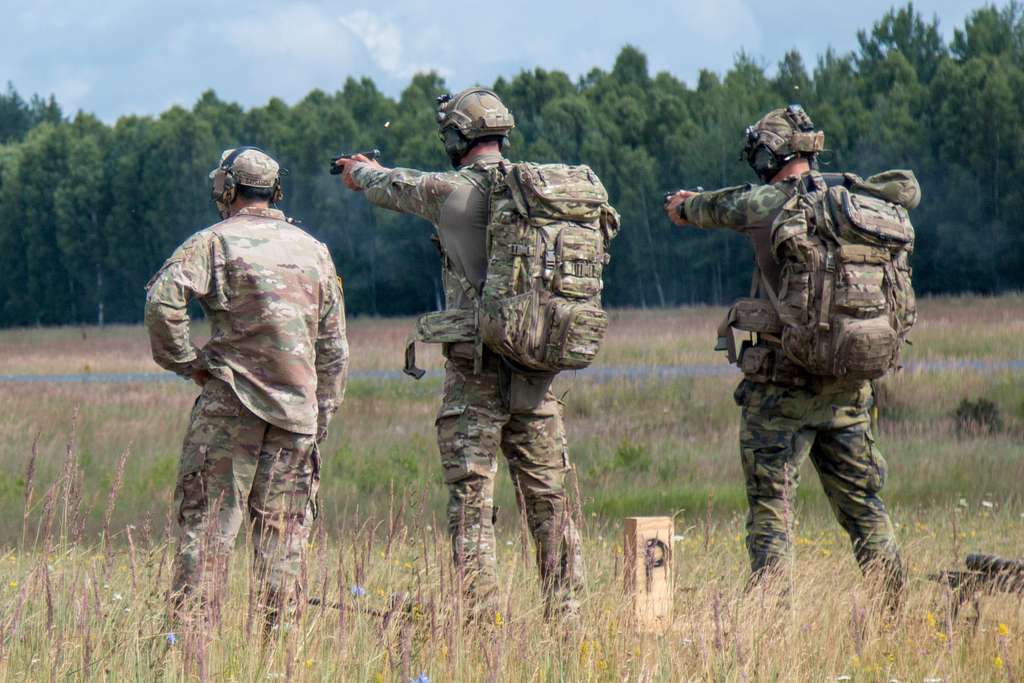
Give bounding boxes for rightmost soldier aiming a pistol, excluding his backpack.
[666,105,920,609]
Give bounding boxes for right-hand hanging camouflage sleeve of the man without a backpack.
[315,249,348,433]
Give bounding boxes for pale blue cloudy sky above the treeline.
[0,0,983,121]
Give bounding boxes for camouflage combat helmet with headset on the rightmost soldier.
[740,104,825,182]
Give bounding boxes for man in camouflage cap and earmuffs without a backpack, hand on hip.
[145,147,348,629]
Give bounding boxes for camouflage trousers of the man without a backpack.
[171,380,319,618]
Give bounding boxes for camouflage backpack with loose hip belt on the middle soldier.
[406,162,618,377]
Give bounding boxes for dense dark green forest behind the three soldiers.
[0,2,1024,326]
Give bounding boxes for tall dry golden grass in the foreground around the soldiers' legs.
[0,436,1024,682]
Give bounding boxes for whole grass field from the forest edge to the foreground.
[0,296,1024,683]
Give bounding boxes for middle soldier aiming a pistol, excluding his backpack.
[337,88,584,615]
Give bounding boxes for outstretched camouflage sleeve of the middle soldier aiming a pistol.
[352,164,458,224]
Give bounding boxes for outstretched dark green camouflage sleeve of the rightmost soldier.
[684,184,791,231]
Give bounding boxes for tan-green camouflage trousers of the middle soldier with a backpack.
[437,360,584,614]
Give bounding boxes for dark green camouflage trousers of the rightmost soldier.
[735,380,901,581]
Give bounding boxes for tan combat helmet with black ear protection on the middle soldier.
[437,87,515,168]
